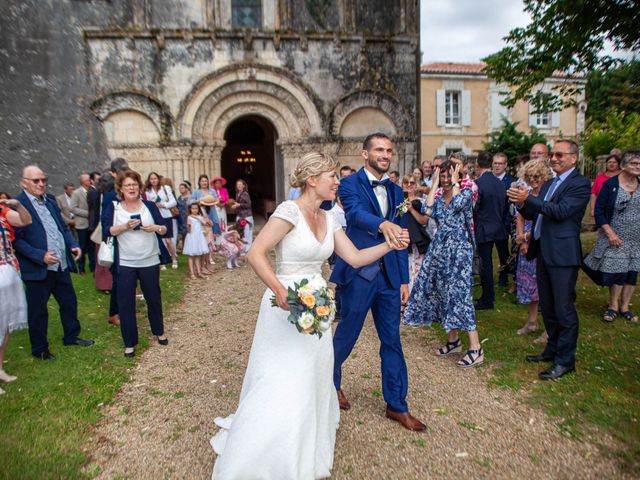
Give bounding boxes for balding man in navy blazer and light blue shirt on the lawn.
[13,166,94,360]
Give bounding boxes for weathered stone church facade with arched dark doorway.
[0,0,420,214]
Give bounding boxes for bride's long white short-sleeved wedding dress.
[211,201,341,480]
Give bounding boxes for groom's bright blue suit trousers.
[333,271,409,413]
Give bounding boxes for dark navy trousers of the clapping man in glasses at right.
[536,255,579,367]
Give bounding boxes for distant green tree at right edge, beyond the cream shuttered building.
[587,60,640,122]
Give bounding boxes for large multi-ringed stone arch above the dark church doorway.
[178,64,324,143]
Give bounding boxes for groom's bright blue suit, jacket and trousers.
[331,168,409,413]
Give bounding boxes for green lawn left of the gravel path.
[0,257,187,479]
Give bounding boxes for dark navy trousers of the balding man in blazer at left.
[24,269,80,355]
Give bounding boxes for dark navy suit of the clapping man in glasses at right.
[520,170,591,367]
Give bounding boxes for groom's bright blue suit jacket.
[331,168,409,288]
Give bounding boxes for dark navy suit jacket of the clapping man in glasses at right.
[520,170,591,267]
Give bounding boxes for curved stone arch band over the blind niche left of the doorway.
[91,92,175,141]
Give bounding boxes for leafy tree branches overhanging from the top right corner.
[483,0,640,111]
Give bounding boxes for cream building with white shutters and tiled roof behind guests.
[420,63,586,161]
